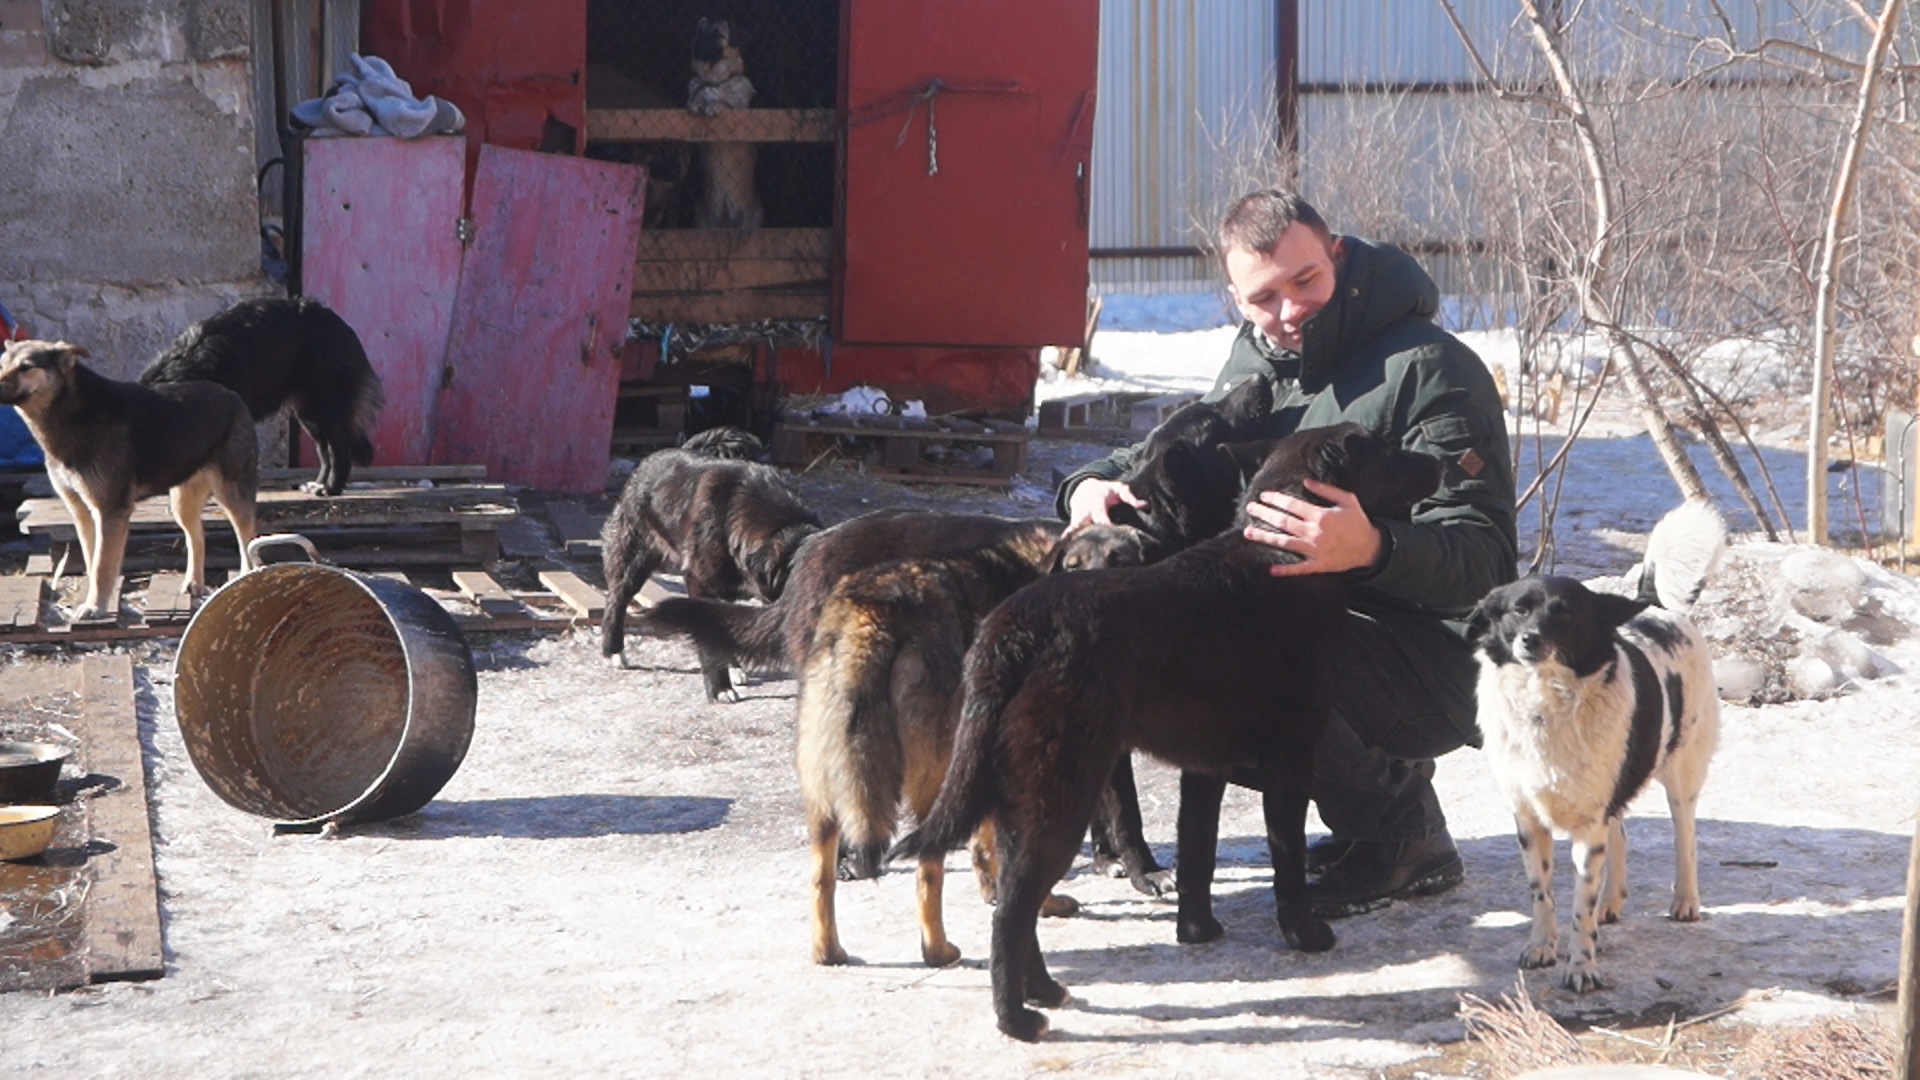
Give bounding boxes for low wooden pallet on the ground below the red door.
[774,415,1029,486]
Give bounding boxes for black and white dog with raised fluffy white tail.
[1469,503,1726,994]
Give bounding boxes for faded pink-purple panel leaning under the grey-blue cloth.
[301,136,467,465]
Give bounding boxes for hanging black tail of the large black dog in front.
[887,617,1031,861]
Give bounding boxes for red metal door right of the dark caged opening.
[837,0,1100,346]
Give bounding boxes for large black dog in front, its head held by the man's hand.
[891,425,1440,1040]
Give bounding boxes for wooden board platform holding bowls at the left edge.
[0,653,165,990]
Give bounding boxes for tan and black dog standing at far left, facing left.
[0,340,259,619]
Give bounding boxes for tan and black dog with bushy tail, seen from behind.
[797,525,1162,967]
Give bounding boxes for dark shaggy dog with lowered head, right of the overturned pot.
[601,429,820,700]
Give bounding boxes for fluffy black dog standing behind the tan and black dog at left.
[140,298,386,496]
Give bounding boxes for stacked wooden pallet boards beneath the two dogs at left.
[19,474,520,573]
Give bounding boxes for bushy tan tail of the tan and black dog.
[795,598,906,878]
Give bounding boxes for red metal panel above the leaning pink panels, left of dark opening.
[363,0,588,176]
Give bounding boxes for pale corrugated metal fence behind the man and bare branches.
[1091,0,1870,292]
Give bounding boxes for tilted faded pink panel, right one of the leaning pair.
[434,146,645,492]
